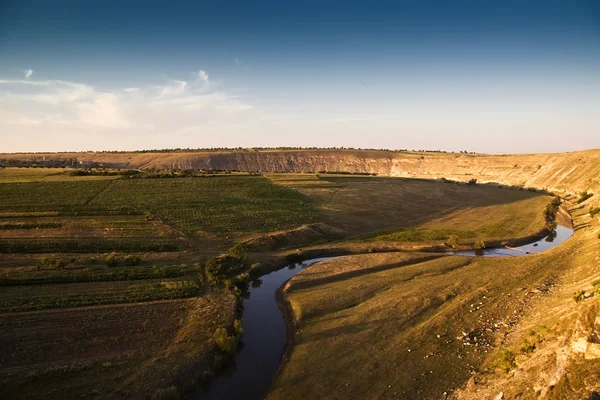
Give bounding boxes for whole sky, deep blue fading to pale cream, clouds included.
[0,0,600,153]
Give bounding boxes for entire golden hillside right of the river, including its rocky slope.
[268,191,600,400]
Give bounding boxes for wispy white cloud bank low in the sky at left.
[0,70,256,151]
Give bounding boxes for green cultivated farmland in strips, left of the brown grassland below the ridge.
[0,175,319,254]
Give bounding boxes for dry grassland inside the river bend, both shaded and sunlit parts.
[269,174,550,243]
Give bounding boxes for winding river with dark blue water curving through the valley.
[191,225,573,400]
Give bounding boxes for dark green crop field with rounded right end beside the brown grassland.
[92,176,317,234]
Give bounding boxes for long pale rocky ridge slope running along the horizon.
[0,150,600,192]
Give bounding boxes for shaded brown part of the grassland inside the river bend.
[302,176,547,234]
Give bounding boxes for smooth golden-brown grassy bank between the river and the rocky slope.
[268,220,577,399]
